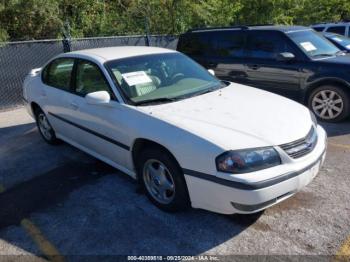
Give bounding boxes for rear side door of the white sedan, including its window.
[40,57,75,140]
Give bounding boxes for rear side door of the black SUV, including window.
[202,29,247,83]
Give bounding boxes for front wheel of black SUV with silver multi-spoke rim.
[308,86,349,122]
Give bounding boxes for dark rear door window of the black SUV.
[211,31,245,57]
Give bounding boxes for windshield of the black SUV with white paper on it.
[288,30,340,58]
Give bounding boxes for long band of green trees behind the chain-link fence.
[0,0,350,41]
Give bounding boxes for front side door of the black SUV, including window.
[246,30,302,99]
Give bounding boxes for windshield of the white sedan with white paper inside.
[106,53,223,104]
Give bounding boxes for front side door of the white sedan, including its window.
[69,59,129,166]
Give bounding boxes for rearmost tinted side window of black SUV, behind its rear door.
[177,33,212,56]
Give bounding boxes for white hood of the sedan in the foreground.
[142,84,312,149]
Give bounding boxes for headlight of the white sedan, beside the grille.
[216,147,281,174]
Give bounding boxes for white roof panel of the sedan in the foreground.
[61,46,176,62]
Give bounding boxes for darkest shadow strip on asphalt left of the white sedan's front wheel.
[0,161,113,229]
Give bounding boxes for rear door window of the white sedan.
[42,58,74,91]
